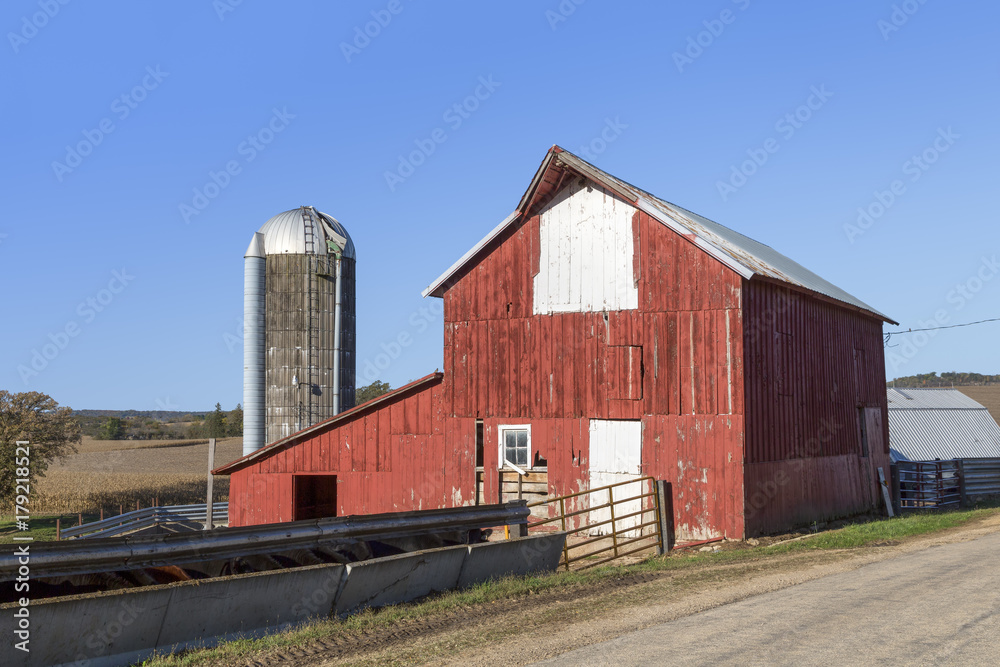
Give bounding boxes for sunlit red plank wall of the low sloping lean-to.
[230,382,475,526]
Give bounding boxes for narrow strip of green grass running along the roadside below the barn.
[101,503,1000,667]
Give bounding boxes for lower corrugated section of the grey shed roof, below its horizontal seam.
[889,410,1000,461]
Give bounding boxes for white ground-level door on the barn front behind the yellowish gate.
[589,419,642,535]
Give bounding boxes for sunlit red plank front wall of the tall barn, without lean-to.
[444,206,744,539]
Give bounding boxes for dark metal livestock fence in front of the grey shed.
[893,458,1000,512]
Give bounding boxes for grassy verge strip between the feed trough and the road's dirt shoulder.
[142,502,1000,667]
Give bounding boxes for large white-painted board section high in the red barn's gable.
[533,177,639,315]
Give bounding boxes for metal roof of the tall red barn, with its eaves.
[423,146,897,324]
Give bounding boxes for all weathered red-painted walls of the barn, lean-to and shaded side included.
[224,149,888,540]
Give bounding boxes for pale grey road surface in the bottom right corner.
[544,533,1000,665]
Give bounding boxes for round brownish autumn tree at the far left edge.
[0,389,80,509]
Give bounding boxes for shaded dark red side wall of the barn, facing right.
[744,280,889,534]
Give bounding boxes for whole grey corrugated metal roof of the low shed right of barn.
[887,389,1000,462]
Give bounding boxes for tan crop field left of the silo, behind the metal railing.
[22,437,243,514]
